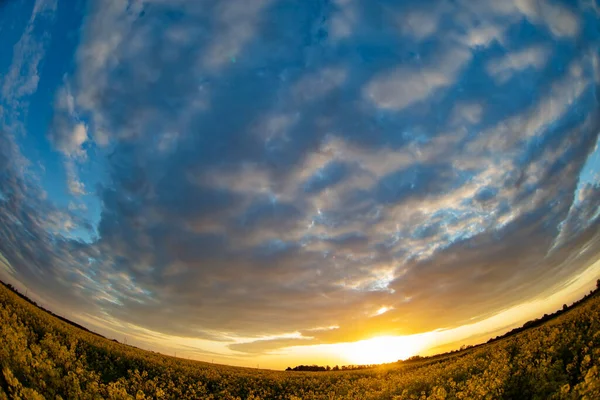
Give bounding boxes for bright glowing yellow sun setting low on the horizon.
[341,334,428,365]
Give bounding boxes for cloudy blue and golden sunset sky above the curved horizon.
[0,0,600,368]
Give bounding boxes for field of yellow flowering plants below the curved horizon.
[0,285,600,400]
